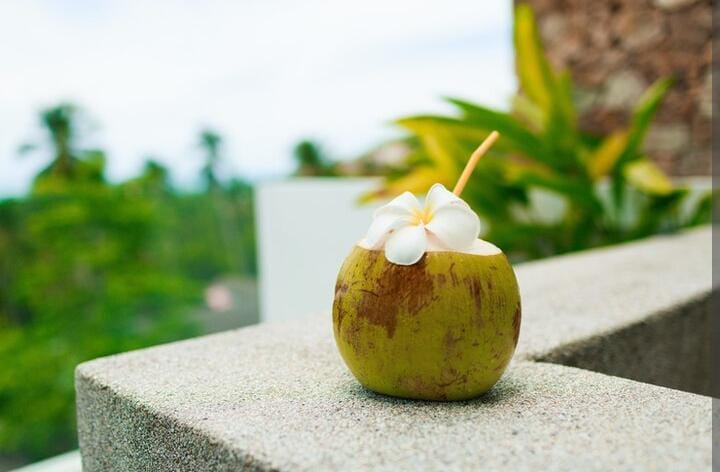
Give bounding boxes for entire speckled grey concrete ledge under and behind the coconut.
[76,228,712,471]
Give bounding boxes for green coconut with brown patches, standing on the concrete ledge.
[333,243,521,400]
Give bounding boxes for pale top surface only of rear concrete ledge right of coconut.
[516,226,713,359]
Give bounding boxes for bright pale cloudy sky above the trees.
[0,0,515,195]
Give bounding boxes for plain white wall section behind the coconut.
[255,178,378,322]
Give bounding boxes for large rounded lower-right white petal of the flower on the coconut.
[425,203,480,249]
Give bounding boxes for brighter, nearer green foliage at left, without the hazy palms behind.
[0,177,199,457]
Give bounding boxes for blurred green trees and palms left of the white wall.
[0,109,255,458]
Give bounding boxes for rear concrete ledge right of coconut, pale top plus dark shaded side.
[517,227,713,395]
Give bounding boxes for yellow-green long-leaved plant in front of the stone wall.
[363,4,711,259]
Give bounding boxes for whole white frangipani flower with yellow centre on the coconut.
[364,184,480,265]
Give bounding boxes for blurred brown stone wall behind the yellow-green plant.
[526,0,713,175]
